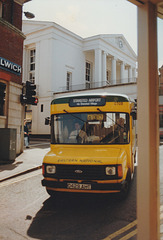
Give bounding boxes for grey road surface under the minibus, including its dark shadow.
[0,156,136,240]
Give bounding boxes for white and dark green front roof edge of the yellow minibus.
[51,93,131,104]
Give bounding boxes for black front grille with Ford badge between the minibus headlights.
[44,164,118,180]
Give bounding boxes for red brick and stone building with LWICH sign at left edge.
[0,0,30,154]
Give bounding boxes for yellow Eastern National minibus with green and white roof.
[42,93,136,197]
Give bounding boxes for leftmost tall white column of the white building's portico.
[95,49,102,86]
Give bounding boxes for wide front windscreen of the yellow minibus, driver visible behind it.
[51,112,129,145]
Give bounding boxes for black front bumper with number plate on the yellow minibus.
[42,179,125,193]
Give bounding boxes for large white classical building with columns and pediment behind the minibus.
[23,21,137,137]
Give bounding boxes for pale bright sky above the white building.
[23,0,163,67]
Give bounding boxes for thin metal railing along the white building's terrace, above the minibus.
[58,78,137,92]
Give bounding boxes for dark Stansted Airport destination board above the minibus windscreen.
[69,97,106,107]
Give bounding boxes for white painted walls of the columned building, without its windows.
[23,21,136,134]
